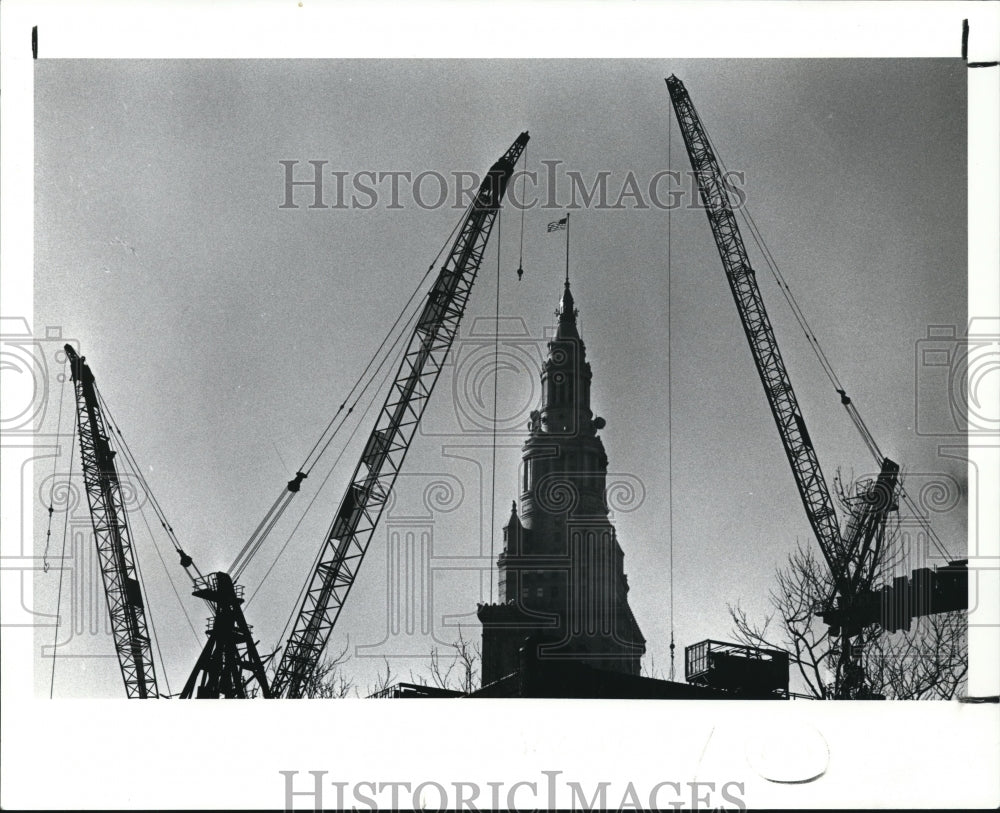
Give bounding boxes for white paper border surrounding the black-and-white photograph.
[0,0,1000,809]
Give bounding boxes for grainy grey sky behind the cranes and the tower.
[34,59,967,697]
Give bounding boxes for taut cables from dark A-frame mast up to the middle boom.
[227,193,475,580]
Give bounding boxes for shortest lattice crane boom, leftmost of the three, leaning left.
[64,344,160,699]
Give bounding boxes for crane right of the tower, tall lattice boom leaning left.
[666,76,899,698]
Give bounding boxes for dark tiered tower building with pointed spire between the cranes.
[478,279,646,686]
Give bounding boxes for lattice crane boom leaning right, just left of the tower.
[270,132,529,698]
